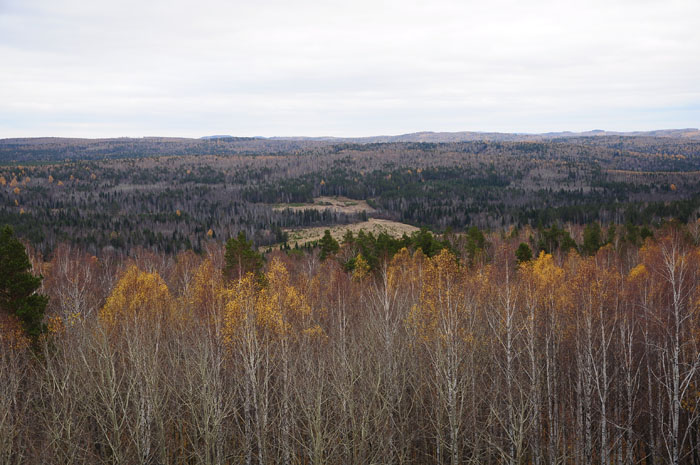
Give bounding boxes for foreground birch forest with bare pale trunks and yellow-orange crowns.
[0,222,700,465]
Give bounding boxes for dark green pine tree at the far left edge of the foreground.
[0,226,49,342]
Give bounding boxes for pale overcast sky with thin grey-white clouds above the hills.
[0,0,700,138]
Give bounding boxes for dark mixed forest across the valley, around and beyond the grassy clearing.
[0,133,700,255]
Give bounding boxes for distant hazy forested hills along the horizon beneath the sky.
[0,129,700,163]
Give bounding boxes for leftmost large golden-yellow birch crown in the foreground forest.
[100,266,175,326]
